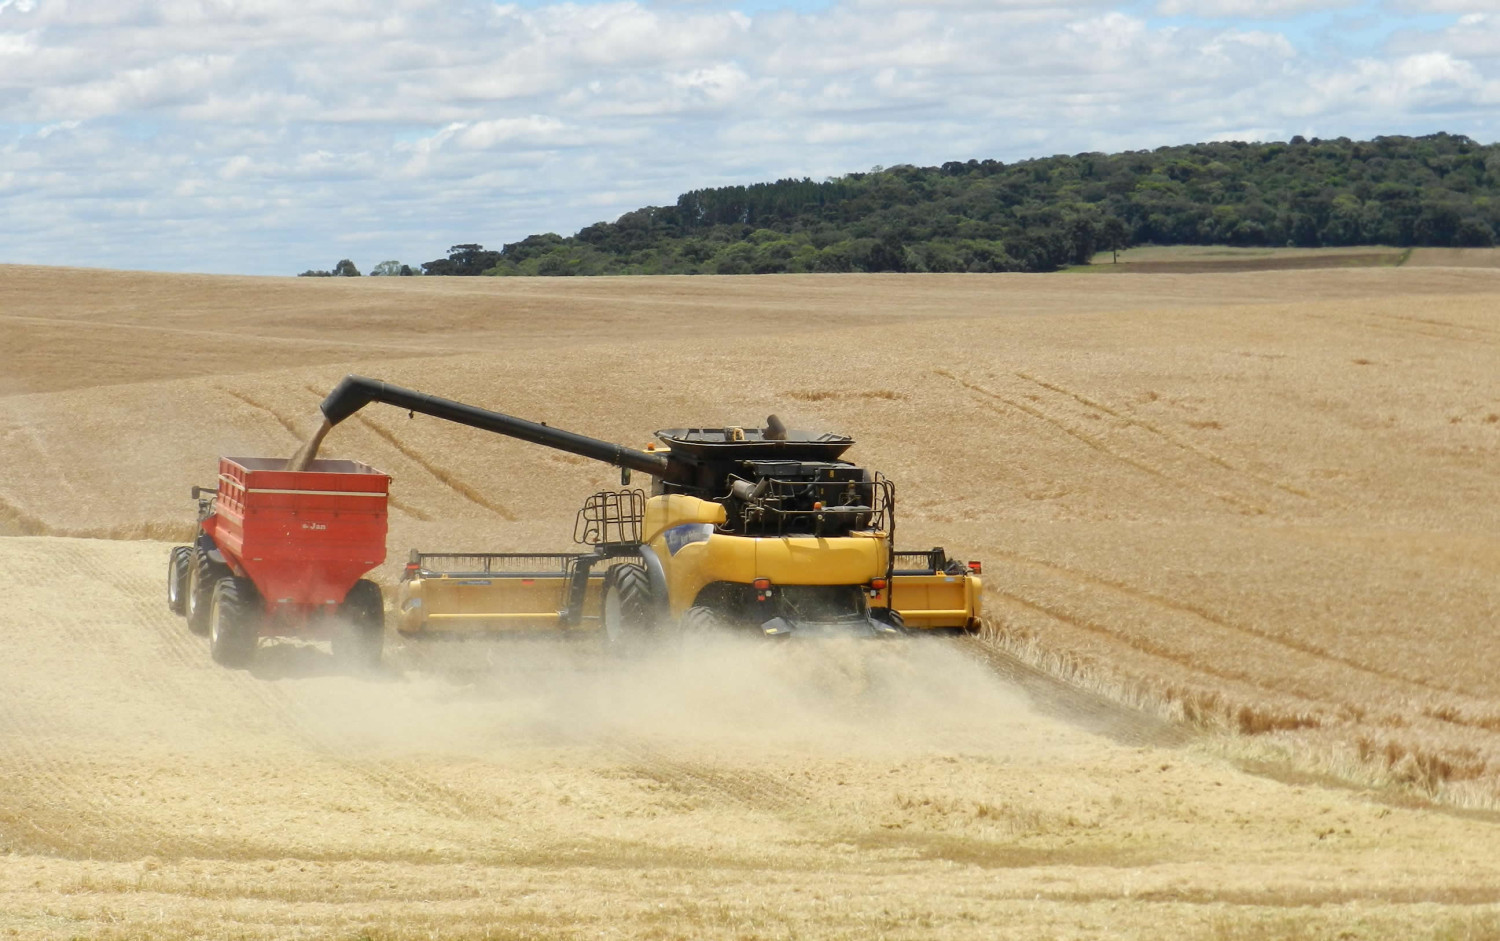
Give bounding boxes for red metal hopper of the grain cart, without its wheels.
[210,458,390,605]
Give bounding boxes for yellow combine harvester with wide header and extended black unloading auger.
[309,375,981,644]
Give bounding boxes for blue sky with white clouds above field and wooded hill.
[0,0,1500,276]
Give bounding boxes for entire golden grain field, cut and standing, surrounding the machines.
[0,259,1500,939]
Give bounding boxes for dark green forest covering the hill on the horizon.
[405,134,1500,275]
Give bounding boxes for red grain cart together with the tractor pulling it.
[167,458,390,666]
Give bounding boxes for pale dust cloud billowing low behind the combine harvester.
[286,638,1050,756]
